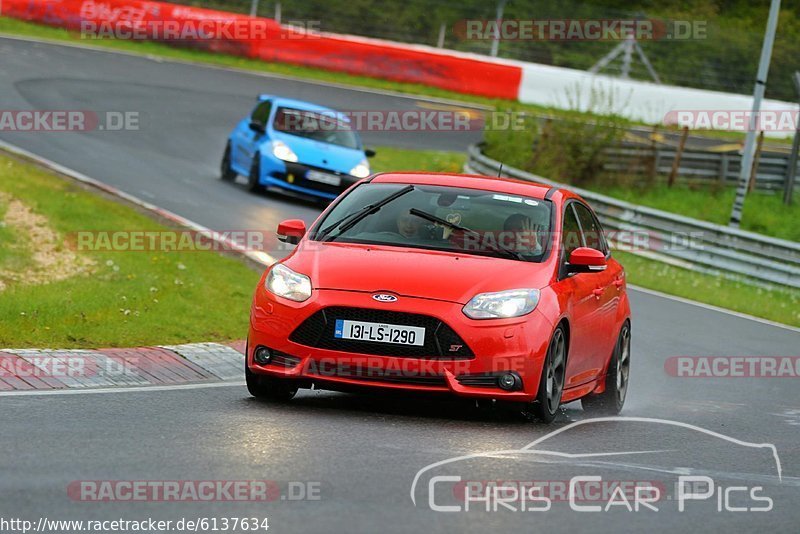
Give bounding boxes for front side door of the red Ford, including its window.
[561,201,613,387]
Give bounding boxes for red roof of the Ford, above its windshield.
[371,172,572,199]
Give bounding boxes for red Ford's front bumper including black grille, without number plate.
[247,250,553,401]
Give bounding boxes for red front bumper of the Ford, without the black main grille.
[247,285,553,402]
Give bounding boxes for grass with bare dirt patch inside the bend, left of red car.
[0,157,259,348]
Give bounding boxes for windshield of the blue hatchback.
[272,107,361,149]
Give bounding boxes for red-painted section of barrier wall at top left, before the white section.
[2,0,522,100]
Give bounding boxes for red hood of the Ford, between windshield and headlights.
[285,241,550,304]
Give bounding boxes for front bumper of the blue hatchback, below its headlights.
[260,156,358,200]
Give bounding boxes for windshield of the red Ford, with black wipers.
[317,184,551,262]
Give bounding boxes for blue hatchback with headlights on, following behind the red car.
[221,95,375,200]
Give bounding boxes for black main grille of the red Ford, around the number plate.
[289,307,475,360]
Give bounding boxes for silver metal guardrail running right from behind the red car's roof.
[465,145,800,288]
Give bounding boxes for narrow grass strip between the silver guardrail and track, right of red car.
[613,251,800,327]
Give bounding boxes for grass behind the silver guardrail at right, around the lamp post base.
[589,184,800,241]
